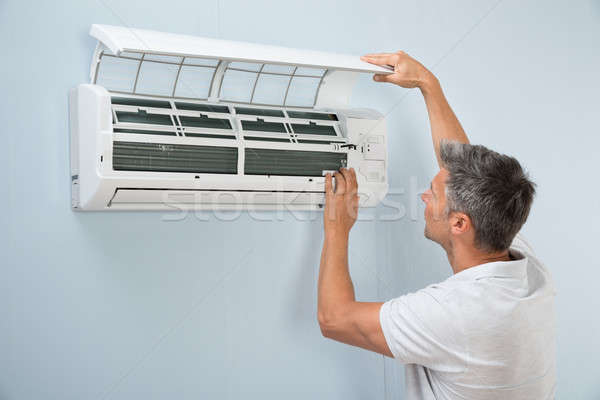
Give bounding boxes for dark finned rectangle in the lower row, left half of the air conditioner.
[113,141,238,174]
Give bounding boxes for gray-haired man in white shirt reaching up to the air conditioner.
[318,52,556,399]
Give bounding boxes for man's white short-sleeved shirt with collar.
[379,235,556,400]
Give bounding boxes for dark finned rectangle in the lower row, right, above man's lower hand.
[244,148,347,176]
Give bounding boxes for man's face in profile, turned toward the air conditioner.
[421,168,450,248]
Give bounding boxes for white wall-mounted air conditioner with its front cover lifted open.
[70,25,389,210]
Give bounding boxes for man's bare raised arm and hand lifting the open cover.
[361,51,469,168]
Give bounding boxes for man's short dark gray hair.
[440,140,535,252]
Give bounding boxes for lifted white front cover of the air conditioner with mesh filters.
[91,25,389,108]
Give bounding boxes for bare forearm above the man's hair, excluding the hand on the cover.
[420,74,469,167]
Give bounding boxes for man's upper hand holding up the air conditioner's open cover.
[360,51,436,89]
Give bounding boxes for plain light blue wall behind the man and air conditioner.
[0,0,600,399]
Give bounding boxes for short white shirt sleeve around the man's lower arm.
[379,285,468,372]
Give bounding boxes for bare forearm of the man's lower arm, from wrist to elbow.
[318,232,355,323]
